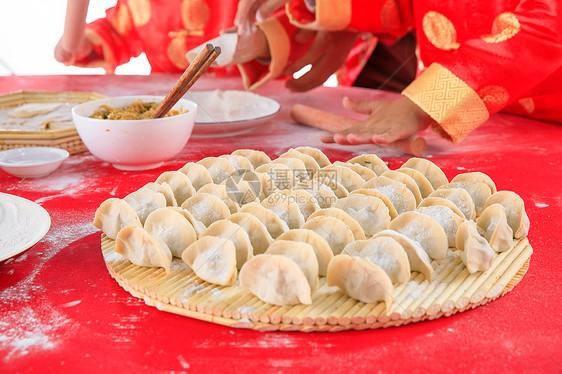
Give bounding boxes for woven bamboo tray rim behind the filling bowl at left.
[0,91,103,154]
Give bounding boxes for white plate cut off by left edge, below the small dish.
[0,192,51,261]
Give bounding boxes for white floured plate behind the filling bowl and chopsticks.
[185,90,281,138]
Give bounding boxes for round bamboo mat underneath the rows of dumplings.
[101,235,533,332]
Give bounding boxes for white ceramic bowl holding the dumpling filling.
[72,96,197,170]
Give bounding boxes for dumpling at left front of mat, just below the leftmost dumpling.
[115,226,172,273]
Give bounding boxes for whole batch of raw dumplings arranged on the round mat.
[94,147,529,308]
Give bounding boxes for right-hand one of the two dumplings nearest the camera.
[326,254,394,309]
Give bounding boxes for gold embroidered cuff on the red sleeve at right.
[402,63,490,143]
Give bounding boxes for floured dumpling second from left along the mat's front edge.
[181,236,237,286]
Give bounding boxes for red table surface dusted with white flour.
[0,75,562,372]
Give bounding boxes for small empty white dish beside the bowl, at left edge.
[0,147,68,178]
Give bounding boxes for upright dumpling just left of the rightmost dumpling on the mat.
[476,204,514,252]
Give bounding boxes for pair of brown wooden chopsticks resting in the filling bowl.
[154,44,221,118]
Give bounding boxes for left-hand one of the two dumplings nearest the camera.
[238,254,312,306]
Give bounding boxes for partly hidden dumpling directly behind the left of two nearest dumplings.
[265,239,320,292]
